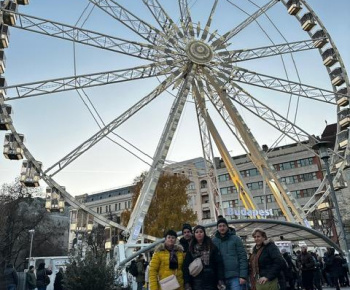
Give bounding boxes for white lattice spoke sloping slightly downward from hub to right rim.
[218,67,336,105]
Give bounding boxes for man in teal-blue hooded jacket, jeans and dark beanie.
[213,216,248,290]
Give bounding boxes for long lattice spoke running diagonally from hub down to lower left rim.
[45,69,181,176]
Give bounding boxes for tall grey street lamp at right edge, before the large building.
[312,141,350,263]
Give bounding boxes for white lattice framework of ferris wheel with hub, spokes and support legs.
[0,0,350,284]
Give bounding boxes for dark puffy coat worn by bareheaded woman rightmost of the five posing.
[249,240,286,281]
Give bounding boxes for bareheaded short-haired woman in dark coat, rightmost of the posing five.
[249,228,286,290]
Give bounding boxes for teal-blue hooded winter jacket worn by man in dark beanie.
[213,228,248,279]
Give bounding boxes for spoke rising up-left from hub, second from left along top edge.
[142,0,184,40]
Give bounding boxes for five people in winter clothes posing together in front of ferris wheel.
[148,217,284,290]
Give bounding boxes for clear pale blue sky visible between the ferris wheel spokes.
[0,0,350,195]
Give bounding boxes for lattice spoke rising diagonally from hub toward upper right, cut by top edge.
[212,0,279,49]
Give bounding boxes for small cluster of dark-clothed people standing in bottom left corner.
[4,263,64,290]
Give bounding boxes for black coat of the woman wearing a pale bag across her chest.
[182,245,224,290]
